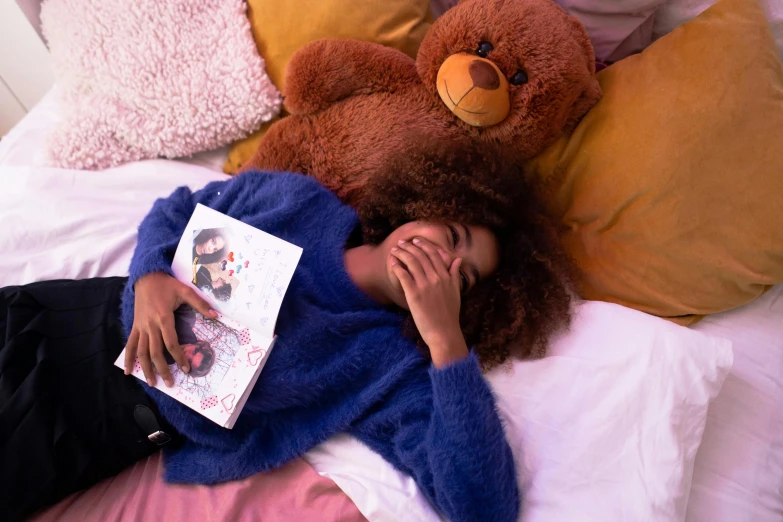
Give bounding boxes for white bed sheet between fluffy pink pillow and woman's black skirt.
[0,89,227,286]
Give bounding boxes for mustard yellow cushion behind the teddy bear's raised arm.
[224,0,432,173]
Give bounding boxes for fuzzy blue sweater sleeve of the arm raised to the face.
[353,354,520,522]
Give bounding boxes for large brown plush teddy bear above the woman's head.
[243,0,601,204]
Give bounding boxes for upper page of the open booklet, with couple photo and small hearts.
[171,204,302,338]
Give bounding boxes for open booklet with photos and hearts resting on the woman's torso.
[115,204,302,429]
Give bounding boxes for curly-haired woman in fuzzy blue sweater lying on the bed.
[0,143,569,521]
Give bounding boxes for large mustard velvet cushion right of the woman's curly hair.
[532,0,783,324]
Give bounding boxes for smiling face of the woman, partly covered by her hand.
[380,221,500,310]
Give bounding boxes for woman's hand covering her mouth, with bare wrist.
[392,238,468,368]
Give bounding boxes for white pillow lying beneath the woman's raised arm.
[306,302,732,522]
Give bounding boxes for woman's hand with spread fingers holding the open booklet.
[125,272,217,386]
